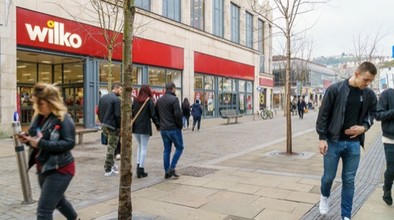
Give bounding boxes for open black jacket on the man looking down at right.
[316,79,377,146]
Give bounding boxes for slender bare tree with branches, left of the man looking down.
[250,0,328,154]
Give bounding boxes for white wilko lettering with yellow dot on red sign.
[25,20,82,48]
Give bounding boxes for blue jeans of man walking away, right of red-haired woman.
[160,129,183,173]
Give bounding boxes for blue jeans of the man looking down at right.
[320,141,360,218]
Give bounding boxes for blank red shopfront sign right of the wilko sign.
[194,52,254,80]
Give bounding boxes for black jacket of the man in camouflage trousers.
[98,92,121,130]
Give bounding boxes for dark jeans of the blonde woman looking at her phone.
[37,172,77,220]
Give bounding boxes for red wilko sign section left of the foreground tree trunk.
[16,7,122,60]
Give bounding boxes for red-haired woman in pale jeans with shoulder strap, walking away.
[132,85,159,178]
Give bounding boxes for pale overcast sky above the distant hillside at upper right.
[274,0,394,57]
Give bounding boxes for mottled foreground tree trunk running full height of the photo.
[118,0,135,220]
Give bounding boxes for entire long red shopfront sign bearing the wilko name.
[16,8,184,69]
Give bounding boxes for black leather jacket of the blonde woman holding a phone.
[28,114,75,173]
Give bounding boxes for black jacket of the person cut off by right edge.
[376,89,394,139]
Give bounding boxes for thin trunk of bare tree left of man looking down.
[285,33,293,154]
